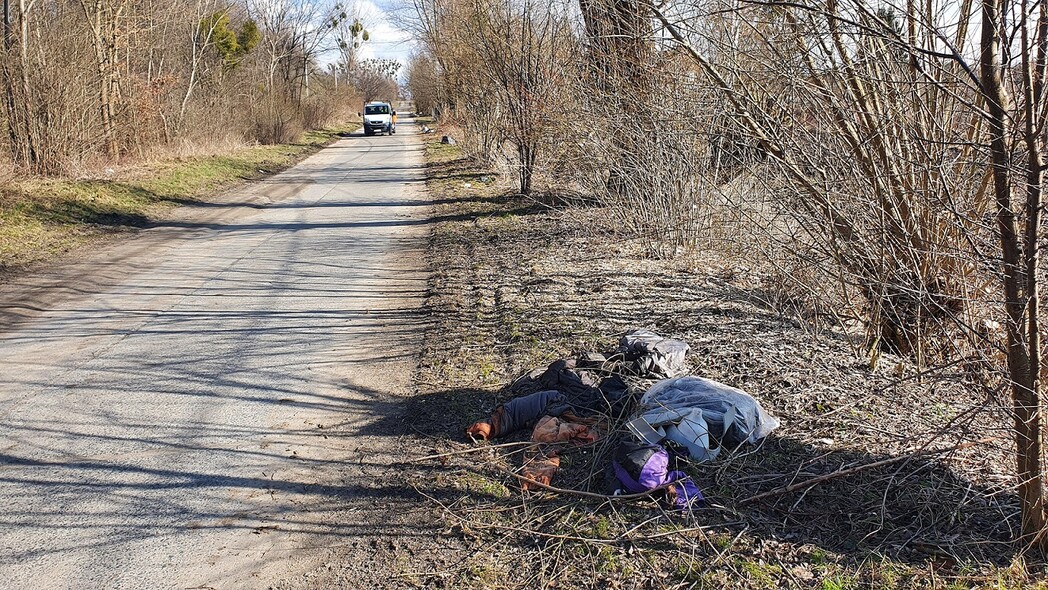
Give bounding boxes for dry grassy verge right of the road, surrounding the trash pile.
[407,131,1046,589]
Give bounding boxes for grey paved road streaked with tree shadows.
[0,122,428,589]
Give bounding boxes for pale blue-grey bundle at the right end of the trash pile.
[626,376,779,461]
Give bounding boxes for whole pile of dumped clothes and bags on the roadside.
[465,330,779,509]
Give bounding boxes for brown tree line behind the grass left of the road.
[0,0,395,174]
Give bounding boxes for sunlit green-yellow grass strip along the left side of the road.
[0,125,355,271]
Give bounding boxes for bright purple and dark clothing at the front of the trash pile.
[612,440,704,509]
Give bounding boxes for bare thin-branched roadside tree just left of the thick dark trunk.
[409,0,578,195]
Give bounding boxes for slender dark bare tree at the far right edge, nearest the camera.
[979,0,1048,552]
